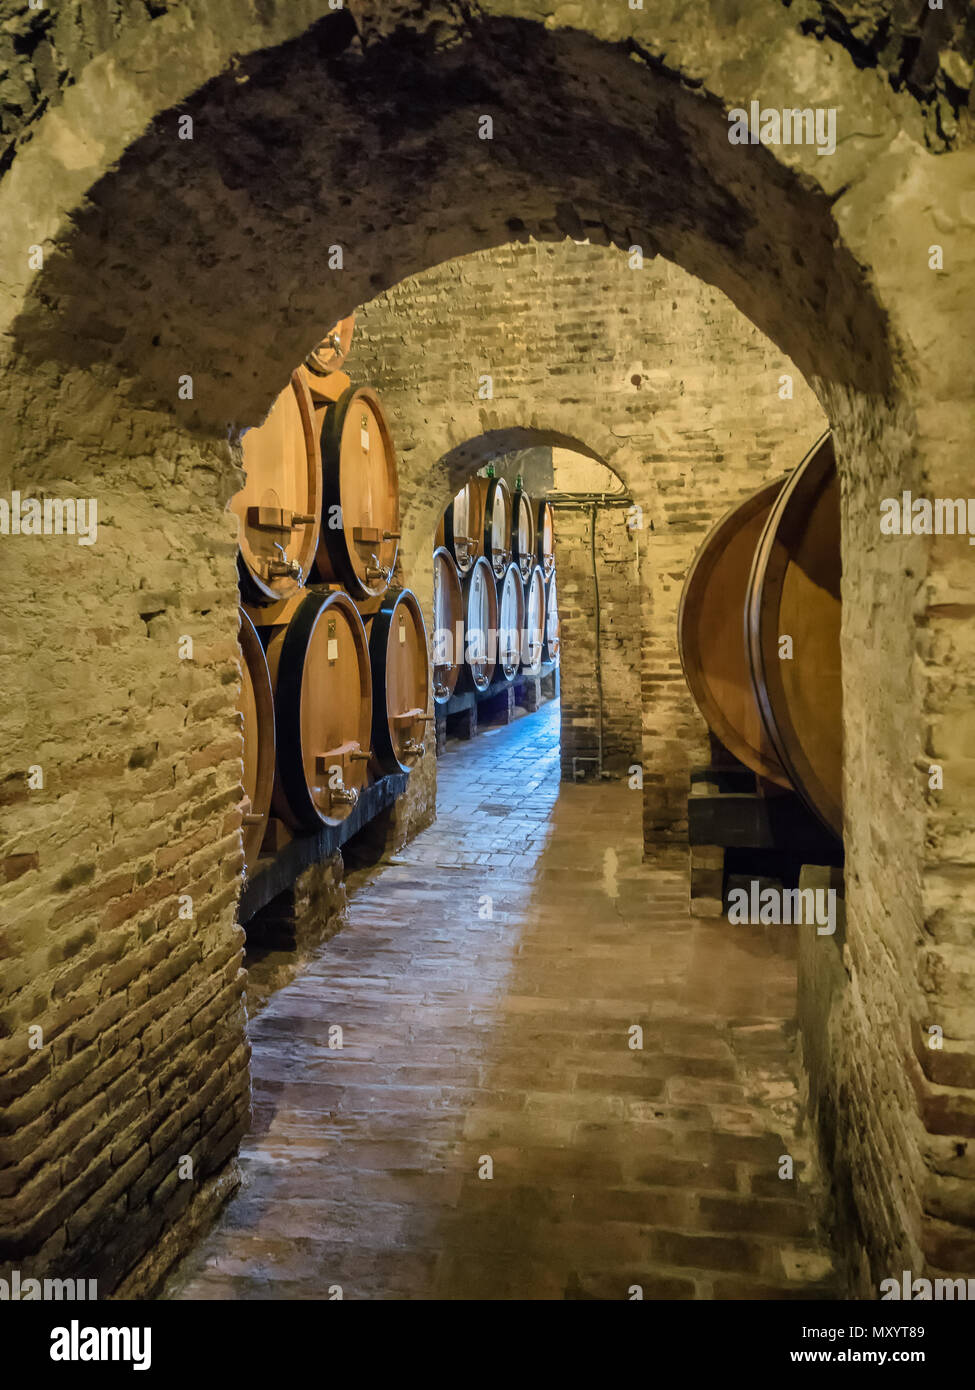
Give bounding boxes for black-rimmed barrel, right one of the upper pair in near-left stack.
[314,386,399,599]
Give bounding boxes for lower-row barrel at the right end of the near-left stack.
[366,588,430,774]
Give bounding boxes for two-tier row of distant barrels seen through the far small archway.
[434,466,559,705]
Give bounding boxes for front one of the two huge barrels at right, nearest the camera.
[746,435,843,835]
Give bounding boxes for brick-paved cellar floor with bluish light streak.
[166,703,835,1300]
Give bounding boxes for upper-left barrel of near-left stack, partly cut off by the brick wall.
[231,373,321,603]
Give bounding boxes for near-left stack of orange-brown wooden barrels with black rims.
[231,318,430,873]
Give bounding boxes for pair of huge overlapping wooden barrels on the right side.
[677,435,843,835]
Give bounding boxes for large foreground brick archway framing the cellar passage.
[0,0,974,1295]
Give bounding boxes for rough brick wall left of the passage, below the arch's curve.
[0,358,249,1291]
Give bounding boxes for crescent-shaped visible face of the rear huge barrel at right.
[677,478,790,787]
